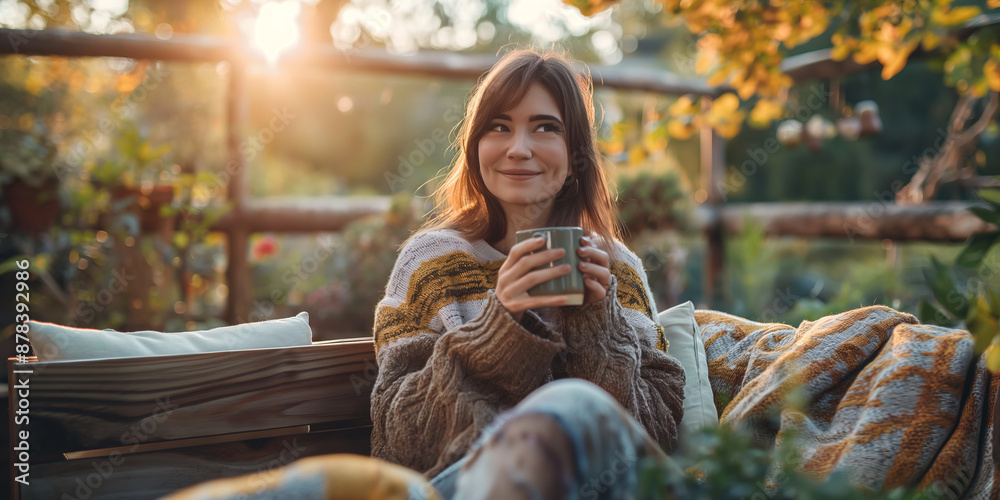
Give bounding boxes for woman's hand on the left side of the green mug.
[495,237,570,321]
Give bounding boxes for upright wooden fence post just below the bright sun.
[225,61,253,325]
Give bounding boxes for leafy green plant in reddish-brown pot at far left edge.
[0,123,60,234]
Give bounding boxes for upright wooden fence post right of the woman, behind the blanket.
[701,97,725,308]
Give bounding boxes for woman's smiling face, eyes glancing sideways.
[479,82,569,219]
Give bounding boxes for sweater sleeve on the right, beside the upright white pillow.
[562,247,685,451]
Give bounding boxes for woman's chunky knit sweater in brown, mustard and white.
[371,230,684,477]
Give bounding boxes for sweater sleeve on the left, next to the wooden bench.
[371,232,565,476]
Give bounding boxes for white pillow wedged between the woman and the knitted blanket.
[657,301,719,436]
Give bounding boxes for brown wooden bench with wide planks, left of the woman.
[8,338,377,500]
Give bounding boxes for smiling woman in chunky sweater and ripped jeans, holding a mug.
[371,50,684,499]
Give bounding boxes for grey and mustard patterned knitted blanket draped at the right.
[695,306,1000,498]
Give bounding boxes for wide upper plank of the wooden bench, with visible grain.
[11,339,377,458]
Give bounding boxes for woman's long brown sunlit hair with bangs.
[419,49,621,260]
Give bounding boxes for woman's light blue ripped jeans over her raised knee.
[431,379,667,500]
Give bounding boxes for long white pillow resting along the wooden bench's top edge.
[28,312,312,361]
